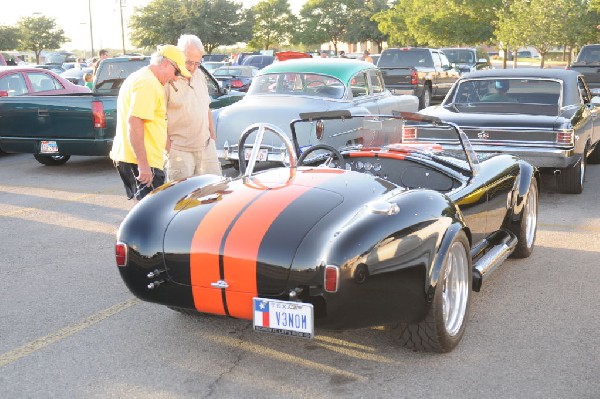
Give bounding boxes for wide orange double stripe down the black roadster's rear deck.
[191,169,343,319]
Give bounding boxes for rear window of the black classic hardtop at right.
[445,77,562,114]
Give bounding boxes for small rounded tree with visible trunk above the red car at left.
[17,16,69,64]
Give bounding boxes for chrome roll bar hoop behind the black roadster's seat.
[238,123,297,177]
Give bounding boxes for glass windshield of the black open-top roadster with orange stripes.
[292,111,480,172]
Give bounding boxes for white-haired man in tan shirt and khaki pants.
[165,35,221,181]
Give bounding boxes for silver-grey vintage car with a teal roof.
[213,58,418,166]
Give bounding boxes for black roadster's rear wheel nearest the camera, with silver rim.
[400,231,473,352]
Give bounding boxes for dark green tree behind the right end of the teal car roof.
[344,0,390,50]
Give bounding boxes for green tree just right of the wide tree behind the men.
[248,0,297,50]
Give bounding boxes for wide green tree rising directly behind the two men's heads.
[129,0,252,54]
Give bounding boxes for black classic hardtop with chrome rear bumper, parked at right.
[418,68,600,194]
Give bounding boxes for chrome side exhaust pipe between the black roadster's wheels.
[473,231,518,292]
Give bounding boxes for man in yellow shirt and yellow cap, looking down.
[110,45,191,200]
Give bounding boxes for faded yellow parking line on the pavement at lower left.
[0,298,140,368]
